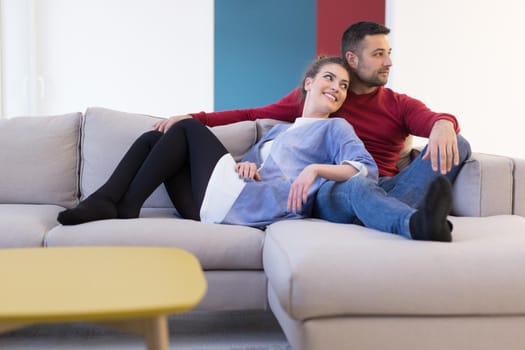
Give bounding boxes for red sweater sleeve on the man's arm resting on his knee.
[399,94,460,138]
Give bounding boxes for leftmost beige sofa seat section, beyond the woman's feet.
[0,204,64,248]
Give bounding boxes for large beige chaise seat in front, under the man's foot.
[263,215,525,350]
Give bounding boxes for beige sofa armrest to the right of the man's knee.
[452,153,512,216]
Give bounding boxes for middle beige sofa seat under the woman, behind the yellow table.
[44,208,268,311]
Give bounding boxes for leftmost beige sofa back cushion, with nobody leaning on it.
[0,113,81,207]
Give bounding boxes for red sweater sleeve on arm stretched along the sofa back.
[190,89,303,126]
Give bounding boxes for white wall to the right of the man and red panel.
[386,0,525,158]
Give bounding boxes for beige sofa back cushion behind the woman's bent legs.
[80,107,256,208]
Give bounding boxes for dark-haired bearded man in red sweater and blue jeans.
[155,22,470,241]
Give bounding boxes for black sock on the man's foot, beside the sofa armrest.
[410,175,452,242]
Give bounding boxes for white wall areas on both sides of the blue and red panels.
[0,0,525,158]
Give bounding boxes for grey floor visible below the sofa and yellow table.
[0,311,291,350]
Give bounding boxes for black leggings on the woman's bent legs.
[94,119,228,220]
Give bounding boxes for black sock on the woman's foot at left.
[57,196,117,225]
